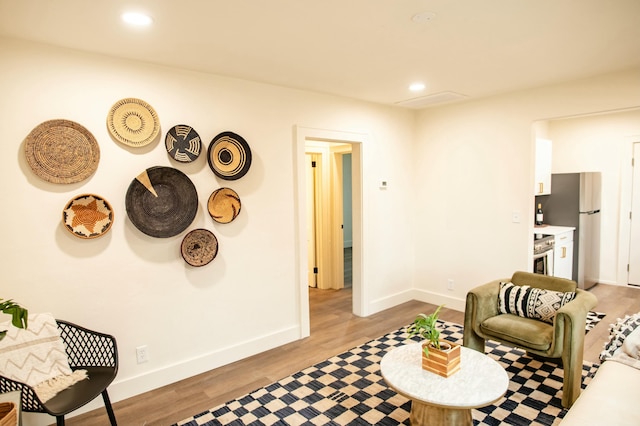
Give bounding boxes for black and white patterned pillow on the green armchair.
[498,282,576,324]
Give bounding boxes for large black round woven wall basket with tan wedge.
[125,166,198,238]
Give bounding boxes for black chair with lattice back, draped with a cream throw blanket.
[0,320,118,426]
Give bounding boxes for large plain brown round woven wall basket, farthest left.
[24,120,100,183]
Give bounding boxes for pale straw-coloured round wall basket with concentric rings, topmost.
[107,98,160,148]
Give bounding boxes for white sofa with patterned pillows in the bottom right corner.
[560,313,640,426]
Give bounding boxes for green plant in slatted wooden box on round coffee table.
[407,305,460,377]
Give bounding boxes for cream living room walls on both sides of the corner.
[0,35,640,424]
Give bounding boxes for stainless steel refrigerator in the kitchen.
[542,172,602,289]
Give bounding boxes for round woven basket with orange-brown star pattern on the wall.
[62,194,113,239]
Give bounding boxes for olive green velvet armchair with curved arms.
[463,272,598,408]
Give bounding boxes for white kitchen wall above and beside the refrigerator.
[548,109,640,285]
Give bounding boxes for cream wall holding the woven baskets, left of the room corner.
[0,39,413,421]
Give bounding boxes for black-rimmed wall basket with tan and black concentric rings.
[208,132,251,180]
